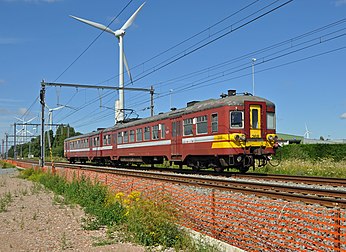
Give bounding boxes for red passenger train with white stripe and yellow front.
[64,90,277,172]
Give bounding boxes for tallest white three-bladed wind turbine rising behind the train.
[70,2,145,122]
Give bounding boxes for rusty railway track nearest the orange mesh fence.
[56,164,346,208]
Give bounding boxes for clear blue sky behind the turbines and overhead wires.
[0,0,346,146]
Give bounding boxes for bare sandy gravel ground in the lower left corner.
[0,169,145,252]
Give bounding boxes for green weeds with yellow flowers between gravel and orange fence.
[20,169,217,251]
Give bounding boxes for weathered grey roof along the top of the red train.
[66,95,275,140]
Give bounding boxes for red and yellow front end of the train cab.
[221,96,278,172]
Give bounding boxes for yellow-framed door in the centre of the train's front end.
[245,102,266,139]
